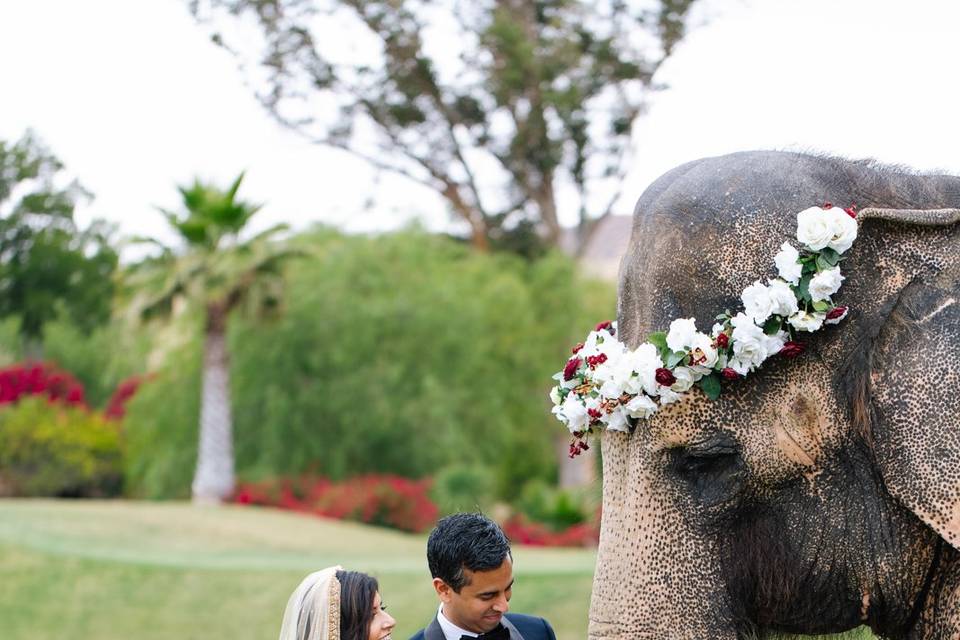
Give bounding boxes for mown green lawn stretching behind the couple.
[0,500,870,640]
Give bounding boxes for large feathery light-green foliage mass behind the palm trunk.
[126,231,615,499]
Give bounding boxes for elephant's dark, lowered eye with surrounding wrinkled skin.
[670,434,746,505]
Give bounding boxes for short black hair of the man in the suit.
[427,513,510,593]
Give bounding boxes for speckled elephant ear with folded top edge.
[858,208,960,549]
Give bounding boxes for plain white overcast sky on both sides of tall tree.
[0,0,960,246]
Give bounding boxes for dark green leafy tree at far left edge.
[0,131,117,343]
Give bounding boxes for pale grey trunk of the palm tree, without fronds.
[193,322,234,504]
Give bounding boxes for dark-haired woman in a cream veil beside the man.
[280,567,396,640]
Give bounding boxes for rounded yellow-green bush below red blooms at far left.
[0,396,122,497]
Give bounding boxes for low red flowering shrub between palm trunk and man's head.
[234,475,439,532]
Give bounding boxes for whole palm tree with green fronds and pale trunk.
[127,174,295,503]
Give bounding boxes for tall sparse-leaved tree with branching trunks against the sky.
[190,0,693,251]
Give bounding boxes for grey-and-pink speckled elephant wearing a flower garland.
[588,151,960,640]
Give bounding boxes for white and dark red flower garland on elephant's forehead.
[550,202,857,458]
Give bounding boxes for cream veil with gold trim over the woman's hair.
[280,567,341,640]
